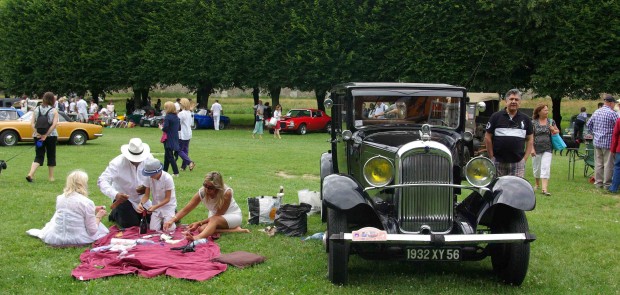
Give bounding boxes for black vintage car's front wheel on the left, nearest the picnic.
[326,208,350,285]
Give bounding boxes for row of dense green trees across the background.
[0,0,620,125]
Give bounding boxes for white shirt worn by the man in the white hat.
[97,155,153,209]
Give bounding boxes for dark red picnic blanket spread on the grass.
[71,226,227,281]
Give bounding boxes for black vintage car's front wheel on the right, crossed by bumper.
[490,208,530,286]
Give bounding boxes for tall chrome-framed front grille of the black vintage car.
[398,148,454,233]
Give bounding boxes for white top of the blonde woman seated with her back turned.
[26,192,109,245]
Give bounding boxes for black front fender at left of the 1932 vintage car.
[322,174,368,211]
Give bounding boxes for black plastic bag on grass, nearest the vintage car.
[275,203,312,237]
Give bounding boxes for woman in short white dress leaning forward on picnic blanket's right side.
[164,171,250,242]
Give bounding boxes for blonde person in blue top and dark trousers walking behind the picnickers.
[160,101,181,177]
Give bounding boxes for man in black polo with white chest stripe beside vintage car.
[484,89,534,178]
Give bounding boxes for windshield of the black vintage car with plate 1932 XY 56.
[354,91,462,128]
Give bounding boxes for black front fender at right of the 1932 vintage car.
[478,176,536,224]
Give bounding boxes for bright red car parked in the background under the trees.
[266,109,332,135]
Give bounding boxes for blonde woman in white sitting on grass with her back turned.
[26,170,110,246]
